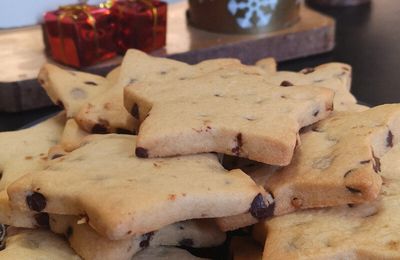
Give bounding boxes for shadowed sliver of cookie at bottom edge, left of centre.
[132,247,206,260]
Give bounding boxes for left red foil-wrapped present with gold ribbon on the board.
[43,4,116,68]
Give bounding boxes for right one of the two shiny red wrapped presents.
[111,0,167,53]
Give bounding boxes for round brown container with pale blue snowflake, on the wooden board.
[187,0,301,34]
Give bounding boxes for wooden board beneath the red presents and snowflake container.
[0,1,335,112]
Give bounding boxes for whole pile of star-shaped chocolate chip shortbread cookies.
[0,50,400,260]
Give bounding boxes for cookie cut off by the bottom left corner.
[0,229,81,260]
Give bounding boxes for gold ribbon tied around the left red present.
[57,4,100,63]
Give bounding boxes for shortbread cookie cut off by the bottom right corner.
[253,145,400,259]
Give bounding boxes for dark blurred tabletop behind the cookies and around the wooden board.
[0,0,400,131]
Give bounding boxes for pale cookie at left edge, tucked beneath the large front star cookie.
[0,113,65,228]
